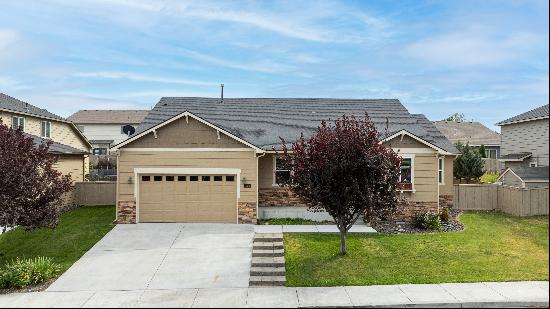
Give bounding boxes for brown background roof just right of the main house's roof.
[434,121,500,145]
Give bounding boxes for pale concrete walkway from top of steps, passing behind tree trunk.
[254,224,376,234]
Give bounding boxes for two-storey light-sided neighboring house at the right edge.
[497,104,550,186]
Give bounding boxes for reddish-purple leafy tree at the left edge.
[0,120,72,230]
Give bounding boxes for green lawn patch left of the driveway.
[0,206,115,272]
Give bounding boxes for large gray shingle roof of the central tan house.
[134,97,458,153]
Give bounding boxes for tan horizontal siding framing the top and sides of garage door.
[117,149,257,203]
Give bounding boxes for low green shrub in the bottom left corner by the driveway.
[0,257,61,289]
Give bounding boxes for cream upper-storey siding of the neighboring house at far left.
[0,112,90,151]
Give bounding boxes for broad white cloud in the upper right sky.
[405,31,537,66]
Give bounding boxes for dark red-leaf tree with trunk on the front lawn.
[282,114,401,255]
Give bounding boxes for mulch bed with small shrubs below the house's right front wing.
[371,209,464,234]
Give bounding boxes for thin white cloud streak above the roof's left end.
[73,71,217,86]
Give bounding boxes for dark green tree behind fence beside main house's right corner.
[453,142,484,183]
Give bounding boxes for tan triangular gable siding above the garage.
[125,117,248,148]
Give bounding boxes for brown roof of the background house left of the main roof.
[68,110,149,124]
